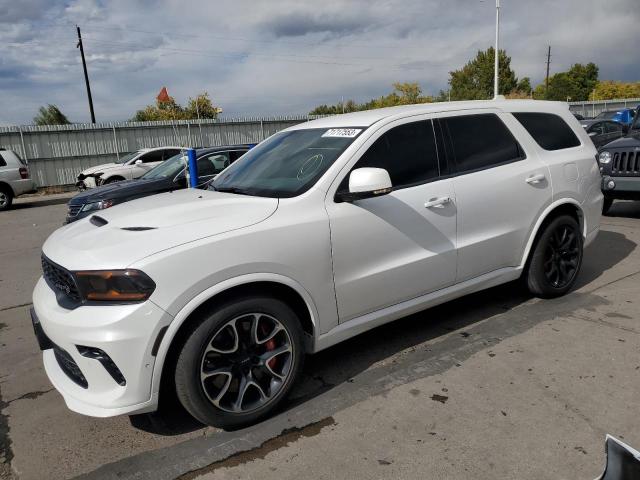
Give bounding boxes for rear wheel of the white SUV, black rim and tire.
[525,215,583,298]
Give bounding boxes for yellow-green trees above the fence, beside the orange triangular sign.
[132,92,222,122]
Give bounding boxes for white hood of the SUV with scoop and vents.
[42,189,278,270]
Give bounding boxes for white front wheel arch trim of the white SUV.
[152,274,318,397]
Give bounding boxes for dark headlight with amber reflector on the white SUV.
[74,269,156,303]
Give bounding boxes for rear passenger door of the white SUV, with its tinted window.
[439,112,552,282]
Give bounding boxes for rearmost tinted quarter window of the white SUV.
[513,112,580,150]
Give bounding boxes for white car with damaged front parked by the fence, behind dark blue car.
[76,147,182,191]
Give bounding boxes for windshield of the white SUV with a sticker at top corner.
[209,127,364,197]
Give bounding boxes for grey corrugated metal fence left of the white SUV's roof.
[0,116,316,187]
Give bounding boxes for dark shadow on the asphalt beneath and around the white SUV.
[130,224,636,436]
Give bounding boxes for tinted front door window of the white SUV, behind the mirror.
[346,120,438,189]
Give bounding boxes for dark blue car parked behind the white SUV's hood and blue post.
[66,145,249,223]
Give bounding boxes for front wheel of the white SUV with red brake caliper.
[174,296,304,430]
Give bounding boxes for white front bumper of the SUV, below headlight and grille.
[33,278,172,417]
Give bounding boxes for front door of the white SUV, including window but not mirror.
[326,119,456,322]
